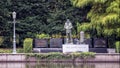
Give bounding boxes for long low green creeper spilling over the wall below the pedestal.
[26,52,95,59]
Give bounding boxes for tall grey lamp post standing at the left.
[12,12,16,54]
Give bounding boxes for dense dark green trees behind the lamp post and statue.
[0,0,88,47]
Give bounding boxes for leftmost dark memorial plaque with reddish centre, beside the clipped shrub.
[34,39,48,48]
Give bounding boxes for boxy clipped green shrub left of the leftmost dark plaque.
[23,38,33,53]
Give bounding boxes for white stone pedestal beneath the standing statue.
[62,44,89,53]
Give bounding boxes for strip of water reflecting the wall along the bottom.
[0,63,120,68]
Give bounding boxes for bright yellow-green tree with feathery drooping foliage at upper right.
[72,0,120,37]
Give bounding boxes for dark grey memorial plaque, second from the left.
[50,38,62,48]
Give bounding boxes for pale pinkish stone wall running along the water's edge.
[0,53,120,62]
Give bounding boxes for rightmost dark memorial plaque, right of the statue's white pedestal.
[94,38,107,47]
